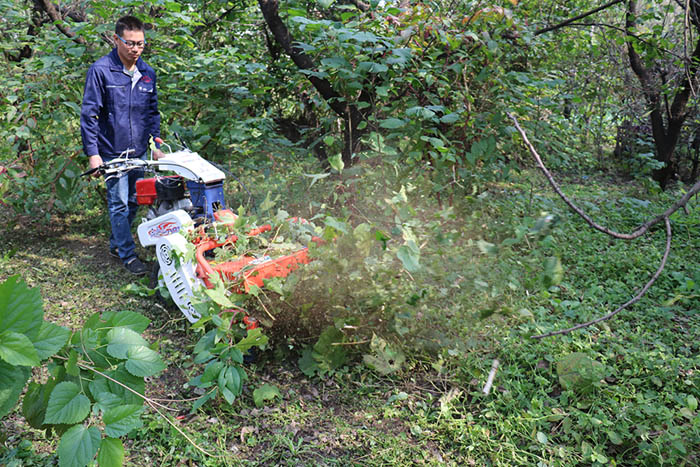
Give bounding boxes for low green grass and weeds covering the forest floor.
[0,164,700,466]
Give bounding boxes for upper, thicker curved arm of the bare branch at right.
[506,112,700,240]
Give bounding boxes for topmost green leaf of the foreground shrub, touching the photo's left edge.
[0,276,44,340]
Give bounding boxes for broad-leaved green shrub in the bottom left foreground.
[0,276,165,466]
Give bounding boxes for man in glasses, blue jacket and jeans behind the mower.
[80,16,163,275]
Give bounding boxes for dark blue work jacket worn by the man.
[80,48,160,159]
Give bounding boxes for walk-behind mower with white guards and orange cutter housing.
[83,145,317,323]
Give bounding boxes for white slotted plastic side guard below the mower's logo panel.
[156,234,202,323]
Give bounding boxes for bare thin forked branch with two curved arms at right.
[506,112,700,340]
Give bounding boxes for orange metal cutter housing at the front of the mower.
[190,210,320,293]
